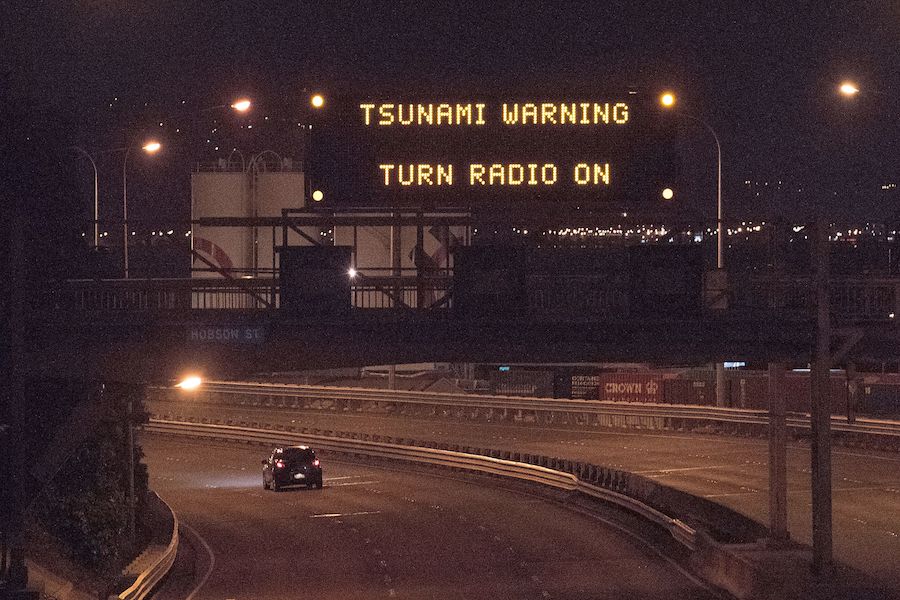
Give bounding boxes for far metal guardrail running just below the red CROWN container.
[181,381,900,440]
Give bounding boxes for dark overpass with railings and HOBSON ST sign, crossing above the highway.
[17,266,900,381]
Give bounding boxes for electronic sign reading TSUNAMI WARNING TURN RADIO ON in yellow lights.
[309,91,679,210]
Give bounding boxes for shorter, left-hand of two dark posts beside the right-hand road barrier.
[768,363,790,545]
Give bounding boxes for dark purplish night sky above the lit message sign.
[0,0,900,227]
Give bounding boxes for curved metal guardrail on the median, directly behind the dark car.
[148,419,697,552]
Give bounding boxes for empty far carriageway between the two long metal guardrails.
[149,401,900,596]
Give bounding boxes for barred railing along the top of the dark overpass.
[52,273,900,322]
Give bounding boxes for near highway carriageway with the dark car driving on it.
[149,434,716,600]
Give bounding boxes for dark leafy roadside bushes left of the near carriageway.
[27,384,152,591]
